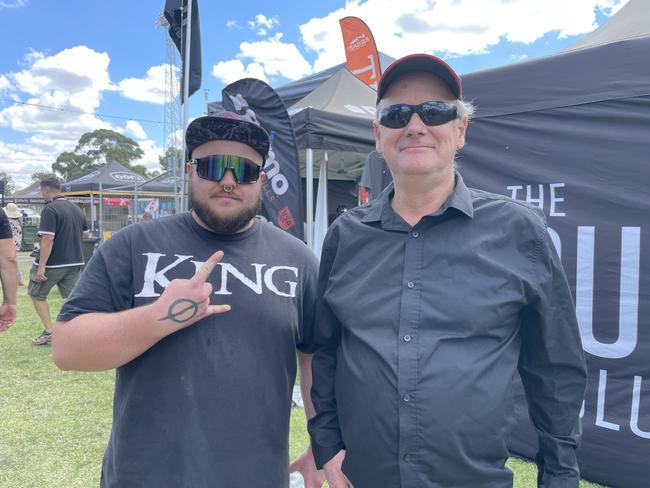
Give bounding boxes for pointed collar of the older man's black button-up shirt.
[361,171,474,224]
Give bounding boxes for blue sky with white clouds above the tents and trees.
[0,0,627,189]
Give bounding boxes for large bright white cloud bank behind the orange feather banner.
[212,0,628,86]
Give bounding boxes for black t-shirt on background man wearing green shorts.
[35,197,88,268]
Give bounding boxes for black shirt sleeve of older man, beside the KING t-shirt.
[308,225,345,468]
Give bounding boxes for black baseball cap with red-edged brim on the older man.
[377,53,463,103]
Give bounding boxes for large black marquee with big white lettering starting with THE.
[458,0,650,488]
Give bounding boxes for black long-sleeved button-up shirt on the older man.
[309,174,586,488]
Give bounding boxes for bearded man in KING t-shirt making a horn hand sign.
[53,112,324,488]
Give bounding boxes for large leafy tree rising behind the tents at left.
[52,129,147,181]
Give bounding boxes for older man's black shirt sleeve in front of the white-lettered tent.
[518,215,587,488]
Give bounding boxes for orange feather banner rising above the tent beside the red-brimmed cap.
[339,17,381,90]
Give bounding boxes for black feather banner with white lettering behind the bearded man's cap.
[222,78,304,240]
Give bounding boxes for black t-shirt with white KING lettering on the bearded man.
[58,213,317,488]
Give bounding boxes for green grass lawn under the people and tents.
[0,253,599,488]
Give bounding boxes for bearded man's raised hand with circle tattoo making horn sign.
[155,251,230,330]
